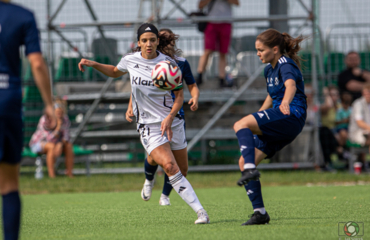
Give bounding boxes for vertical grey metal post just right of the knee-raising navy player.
[311,0,321,166]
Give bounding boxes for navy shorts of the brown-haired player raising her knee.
[252,108,306,158]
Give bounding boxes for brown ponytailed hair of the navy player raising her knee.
[257,28,306,68]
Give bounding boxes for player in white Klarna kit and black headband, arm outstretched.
[78,23,209,224]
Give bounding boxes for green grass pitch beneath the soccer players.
[21,185,370,240]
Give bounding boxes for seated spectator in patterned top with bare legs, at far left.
[30,100,74,178]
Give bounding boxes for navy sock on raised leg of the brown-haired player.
[236,128,254,164]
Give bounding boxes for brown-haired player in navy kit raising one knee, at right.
[234,29,307,225]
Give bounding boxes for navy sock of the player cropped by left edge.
[2,191,21,240]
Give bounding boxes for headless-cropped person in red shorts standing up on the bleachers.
[197,0,239,87]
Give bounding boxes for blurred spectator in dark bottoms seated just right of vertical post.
[319,86,340,169]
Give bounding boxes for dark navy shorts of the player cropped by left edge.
[0,117,23,164]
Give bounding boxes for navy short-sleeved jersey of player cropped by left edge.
[0,1,41,117]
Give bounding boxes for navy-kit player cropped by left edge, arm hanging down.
[0,0,56,240]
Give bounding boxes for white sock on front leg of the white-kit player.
[169,171,203,212]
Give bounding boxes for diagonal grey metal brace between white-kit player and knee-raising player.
[188,65,265,151]
